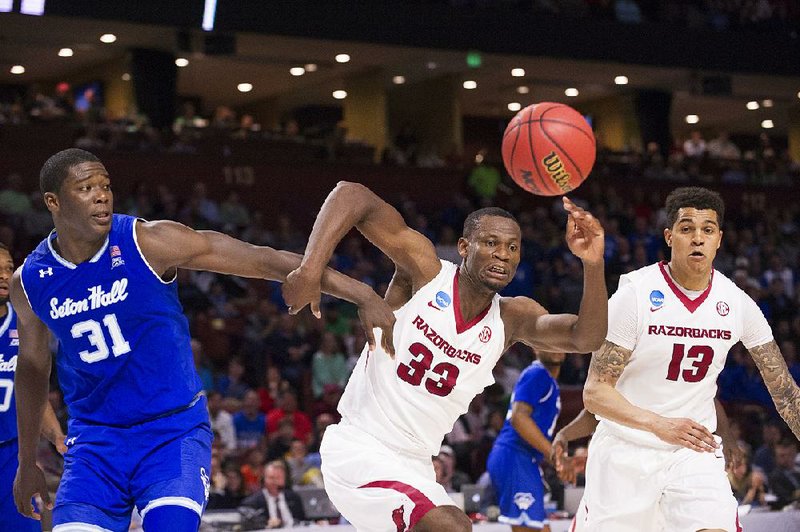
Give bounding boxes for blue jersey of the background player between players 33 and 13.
[495,360,561,462]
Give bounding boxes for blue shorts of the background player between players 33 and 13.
[486,445,549,528]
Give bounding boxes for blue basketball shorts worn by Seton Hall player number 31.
[53,397,213,532]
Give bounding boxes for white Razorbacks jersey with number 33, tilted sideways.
[339,261,505,457]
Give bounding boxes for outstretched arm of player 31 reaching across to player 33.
[136,220,395,347]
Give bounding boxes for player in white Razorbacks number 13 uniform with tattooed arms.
[583,187,800,532]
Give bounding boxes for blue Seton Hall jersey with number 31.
[22,214,201,427]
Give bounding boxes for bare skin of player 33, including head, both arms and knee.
[283,182,608,531]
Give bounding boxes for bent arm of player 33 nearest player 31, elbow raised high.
[283,181,441,312]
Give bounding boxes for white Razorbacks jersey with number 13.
[601,263,772,448]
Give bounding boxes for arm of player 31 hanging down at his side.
[11,267,54,519]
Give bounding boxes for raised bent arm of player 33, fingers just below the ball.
[506,197,608,353]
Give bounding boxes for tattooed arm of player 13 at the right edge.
[749,340,800,439]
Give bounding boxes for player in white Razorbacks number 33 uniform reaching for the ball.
[284,182,608,532]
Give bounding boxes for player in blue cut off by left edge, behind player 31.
[0,244,66,532]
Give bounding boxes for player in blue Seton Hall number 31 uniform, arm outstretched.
[11,149,392,532]
